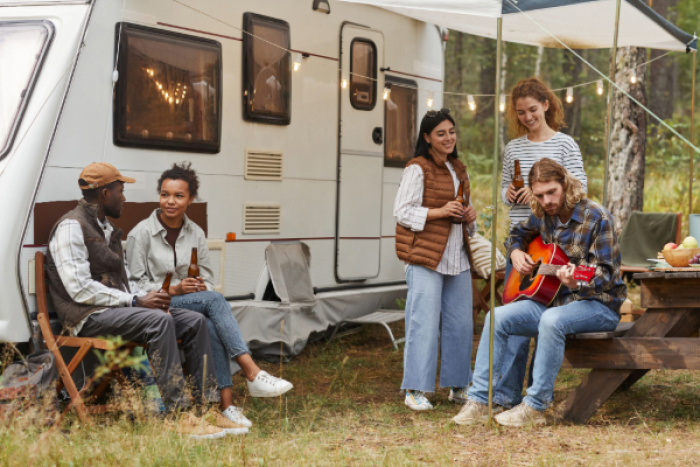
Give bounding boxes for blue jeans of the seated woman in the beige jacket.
[170,291,250,389]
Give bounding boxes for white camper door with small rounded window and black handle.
[335,24,384,281]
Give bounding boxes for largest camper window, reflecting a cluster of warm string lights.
[114,23,221,153]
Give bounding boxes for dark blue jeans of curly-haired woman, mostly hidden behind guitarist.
[493,258,535,407]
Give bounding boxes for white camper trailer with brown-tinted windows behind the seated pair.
[0,0,443,353]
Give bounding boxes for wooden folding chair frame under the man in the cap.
[34,251,139,423]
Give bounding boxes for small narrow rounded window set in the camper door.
[350,39,377,110]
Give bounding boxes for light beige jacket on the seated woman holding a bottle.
[126,209,214,291]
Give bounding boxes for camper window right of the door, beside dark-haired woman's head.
[384,76,418,167]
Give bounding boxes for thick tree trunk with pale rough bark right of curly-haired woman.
[607,47,647,234]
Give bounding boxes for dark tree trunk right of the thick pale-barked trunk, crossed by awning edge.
[649,0,678,123]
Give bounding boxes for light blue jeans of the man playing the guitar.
[468,300,620,411]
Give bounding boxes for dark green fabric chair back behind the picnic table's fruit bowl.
[620,211,678,268]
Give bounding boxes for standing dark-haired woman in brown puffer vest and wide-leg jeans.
[394,109,476,410]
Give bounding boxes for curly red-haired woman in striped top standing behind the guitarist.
[493,77,588,407]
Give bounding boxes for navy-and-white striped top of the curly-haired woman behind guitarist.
[501,132,588,227]
